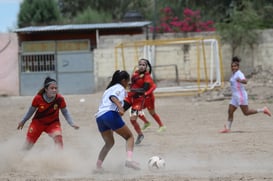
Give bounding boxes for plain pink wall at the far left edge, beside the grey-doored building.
[0,33,19,96]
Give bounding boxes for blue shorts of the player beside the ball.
[96,111,125,132]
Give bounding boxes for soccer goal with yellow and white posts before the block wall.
[115,37,224,95]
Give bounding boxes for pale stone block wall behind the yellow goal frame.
[94,30,273,90]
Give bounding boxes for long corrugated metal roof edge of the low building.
[14,21,151,33]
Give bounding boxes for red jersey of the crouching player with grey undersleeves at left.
[32,94,66,124]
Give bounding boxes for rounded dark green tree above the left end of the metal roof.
[17,0,60,28]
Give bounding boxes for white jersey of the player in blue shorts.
[95,84,126,118]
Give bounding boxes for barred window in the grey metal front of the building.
[21,54,56,72]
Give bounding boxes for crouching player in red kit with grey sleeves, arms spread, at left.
[17,77,79,150]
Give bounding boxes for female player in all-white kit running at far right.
[220,57,271,133]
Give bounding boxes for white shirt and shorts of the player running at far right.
[229,70,248,106]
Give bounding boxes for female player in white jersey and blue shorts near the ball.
[95,70,140,170]
